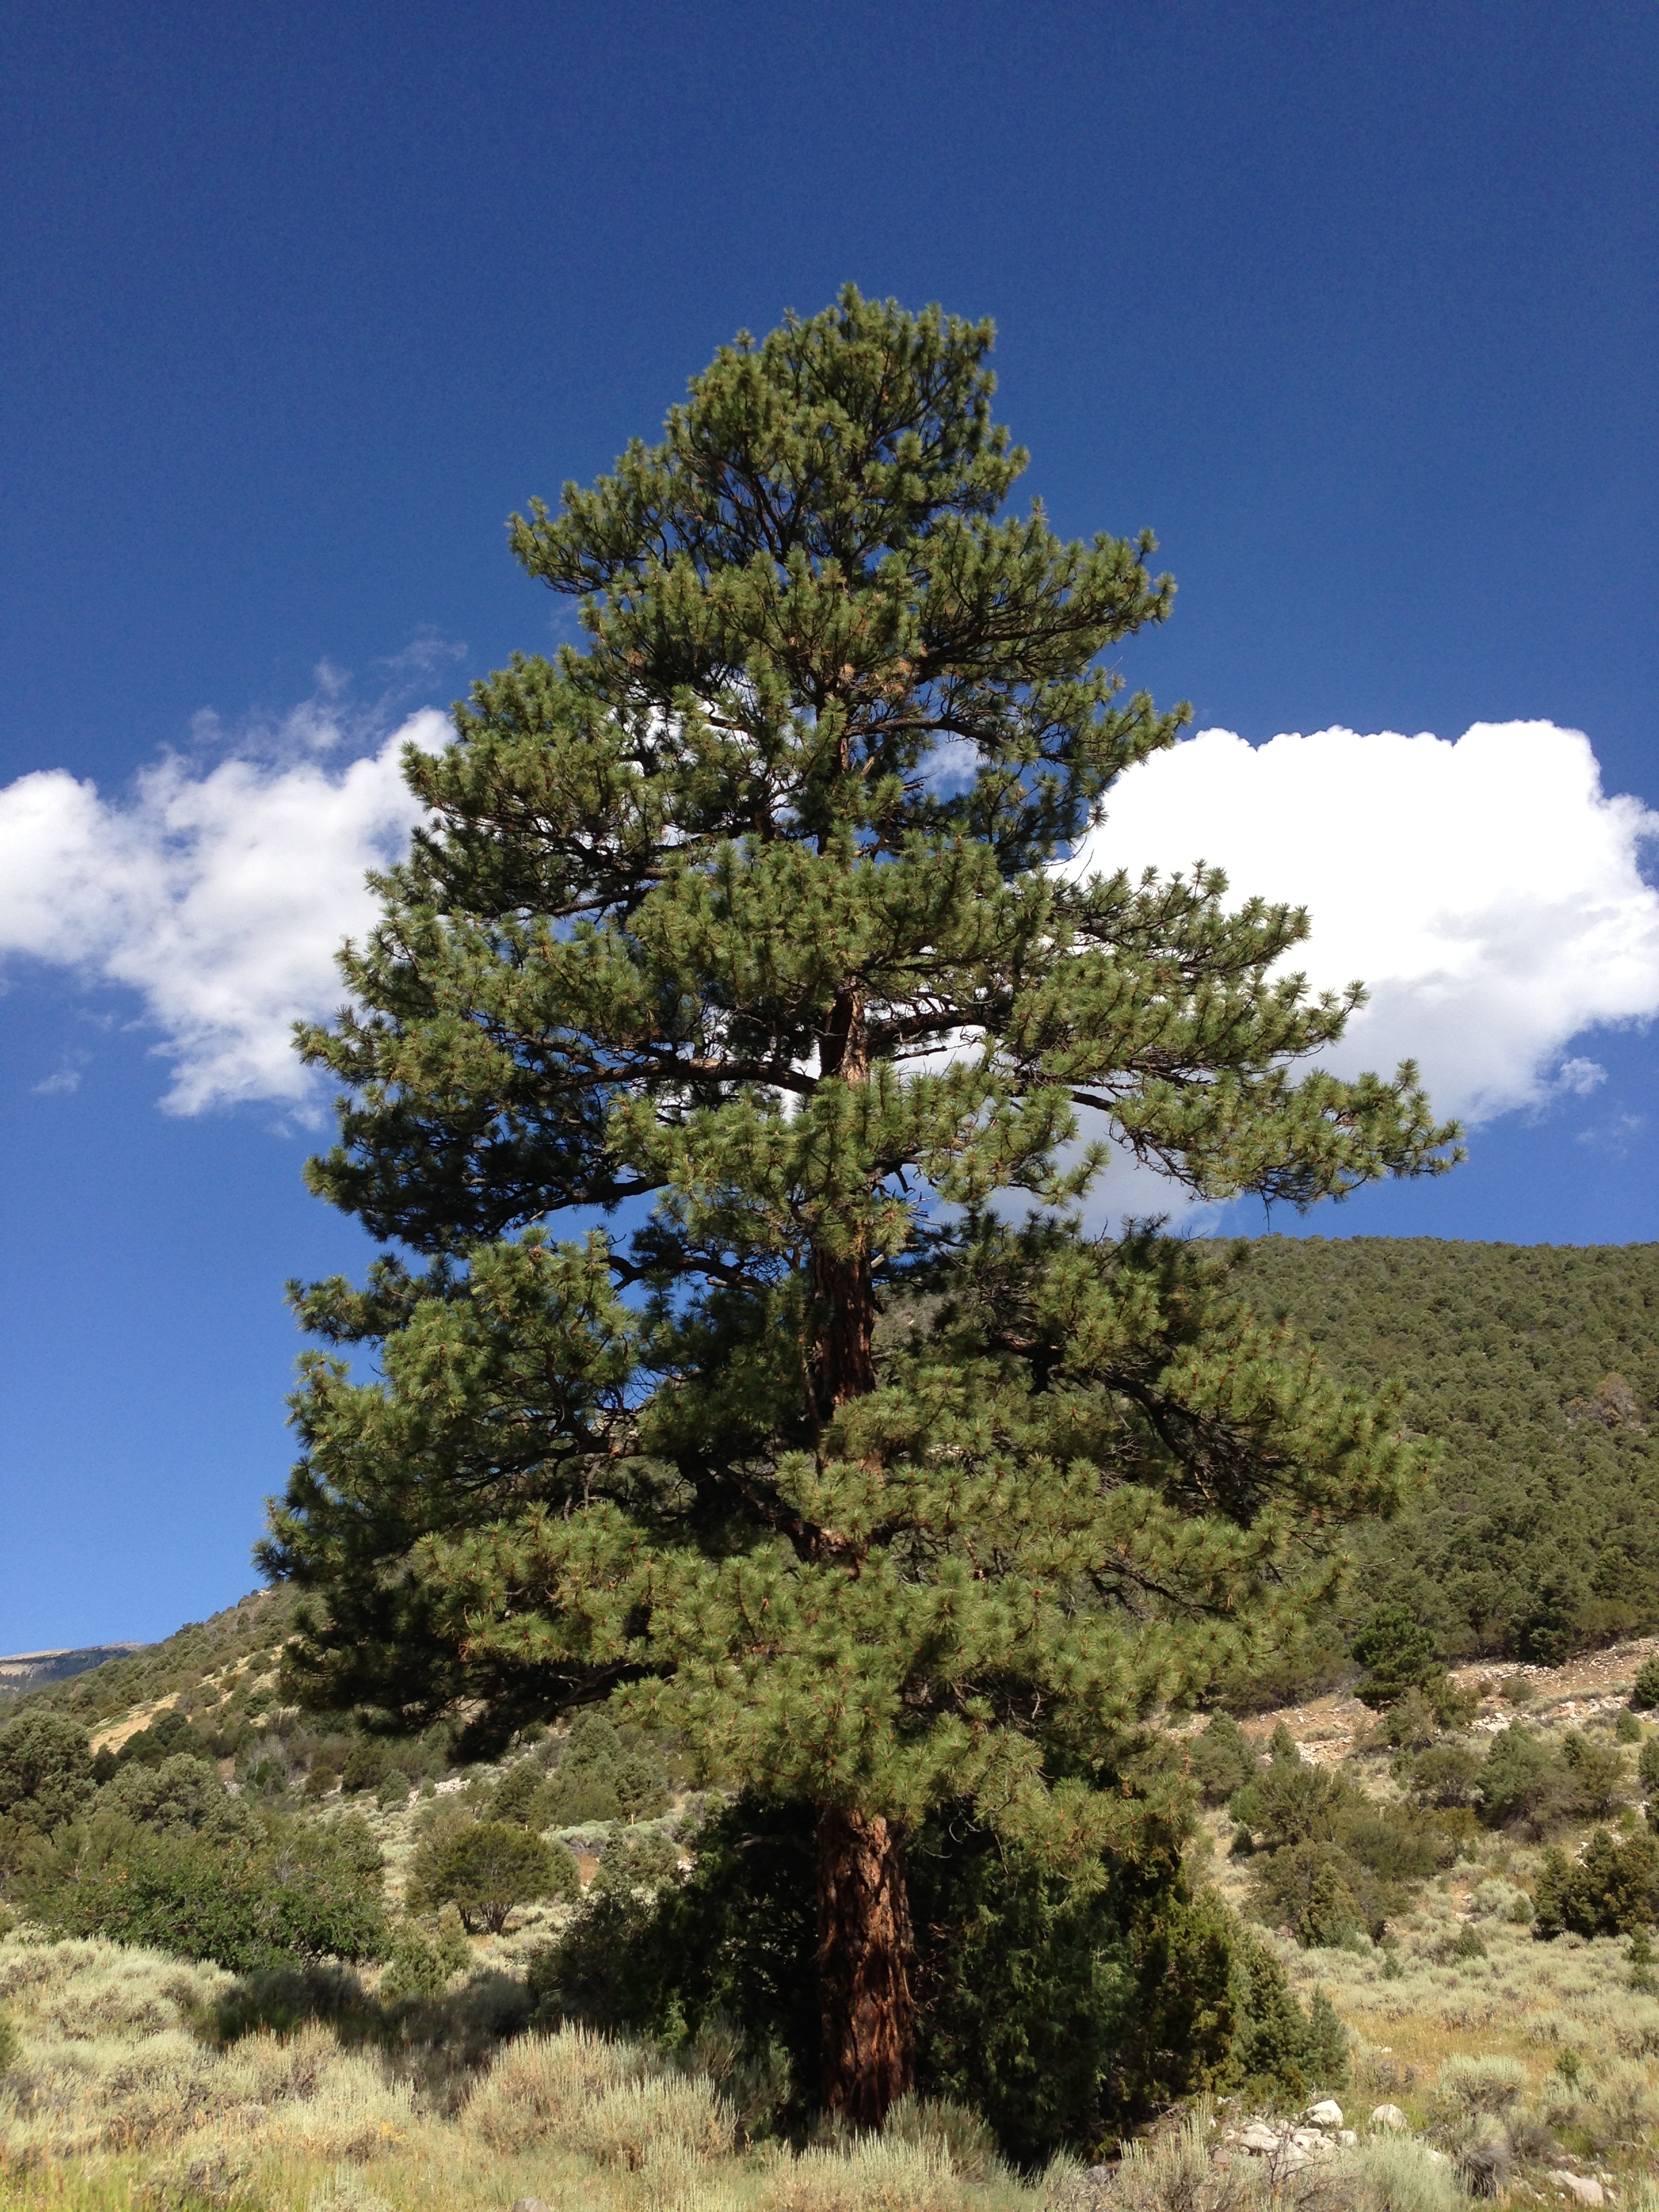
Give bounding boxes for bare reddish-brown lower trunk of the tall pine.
[819,1805,916,2128]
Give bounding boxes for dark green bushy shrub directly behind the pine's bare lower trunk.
[529,1799,1340,2161]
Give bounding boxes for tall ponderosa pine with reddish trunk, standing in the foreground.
[263,290,1451,2121]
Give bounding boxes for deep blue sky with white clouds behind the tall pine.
[0,0,1659,1650]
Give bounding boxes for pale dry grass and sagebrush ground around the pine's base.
[0,1648,1659,2212]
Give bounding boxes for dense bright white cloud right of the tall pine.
[1078,721,1659,1122]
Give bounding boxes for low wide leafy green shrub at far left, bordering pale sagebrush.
[28,1814,385,1973]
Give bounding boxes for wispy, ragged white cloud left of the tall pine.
[0,712,447,1113]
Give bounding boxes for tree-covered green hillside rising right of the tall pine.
[1239,1237,1659,1664]
